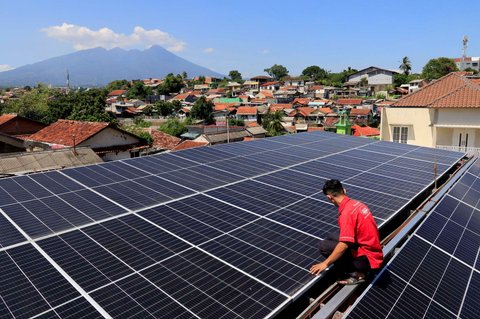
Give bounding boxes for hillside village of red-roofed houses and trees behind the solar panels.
[0,59,480,174]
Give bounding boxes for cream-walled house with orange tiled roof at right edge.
[380,72,480,152]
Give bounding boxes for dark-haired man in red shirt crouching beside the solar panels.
[310,179,383,285]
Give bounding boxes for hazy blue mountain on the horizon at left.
[0,46,223,87]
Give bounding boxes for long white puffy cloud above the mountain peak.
[41,23,186,52]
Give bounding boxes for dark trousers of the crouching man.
[320,232,371,273]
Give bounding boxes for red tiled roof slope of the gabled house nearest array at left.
[28,120,111,146]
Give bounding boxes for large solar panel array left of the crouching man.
[0,132,462,318]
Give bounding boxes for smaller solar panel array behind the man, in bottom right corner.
[347,160,480,318]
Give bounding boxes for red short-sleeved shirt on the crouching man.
[338,196,383,269]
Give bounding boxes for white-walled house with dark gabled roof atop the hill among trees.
[348,66,399,92]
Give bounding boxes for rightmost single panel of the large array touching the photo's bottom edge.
[141,249,286,318]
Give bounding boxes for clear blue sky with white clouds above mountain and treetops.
[0,0,480,78]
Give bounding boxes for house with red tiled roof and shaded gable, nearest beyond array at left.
[26,120,148,161]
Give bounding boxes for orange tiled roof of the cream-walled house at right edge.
[391,72,480,108]
